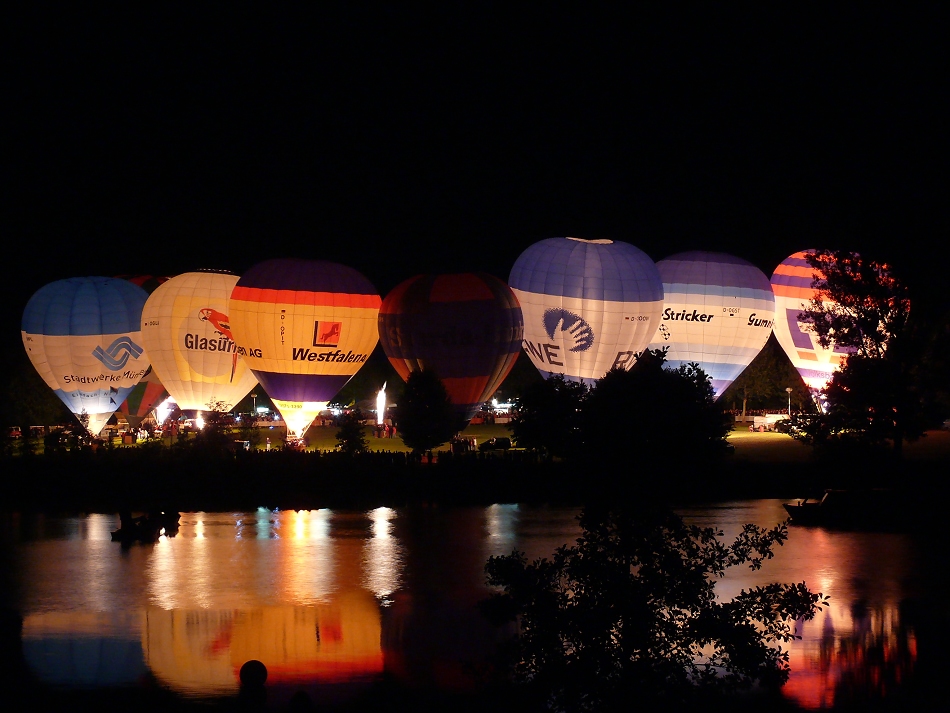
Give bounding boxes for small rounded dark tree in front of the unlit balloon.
[395,368,456,453]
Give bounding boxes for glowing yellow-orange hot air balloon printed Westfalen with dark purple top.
[231,259,381,438]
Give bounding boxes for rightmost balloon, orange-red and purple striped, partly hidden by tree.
[772,250,852,391]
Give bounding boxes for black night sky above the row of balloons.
[0,2,950,334]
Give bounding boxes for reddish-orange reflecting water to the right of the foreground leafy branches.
[683,500,927,709]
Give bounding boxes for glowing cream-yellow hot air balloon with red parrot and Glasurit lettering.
[142,270,257,412]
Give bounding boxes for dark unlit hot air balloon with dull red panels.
[379,273,524,427]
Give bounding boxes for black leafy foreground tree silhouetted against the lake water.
[484,505,827,712]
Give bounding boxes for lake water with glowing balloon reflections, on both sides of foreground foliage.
[0,500,940,709]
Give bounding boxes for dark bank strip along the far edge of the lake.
[0,432,950,514]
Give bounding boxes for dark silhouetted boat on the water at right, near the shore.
[783,488,913,529]
